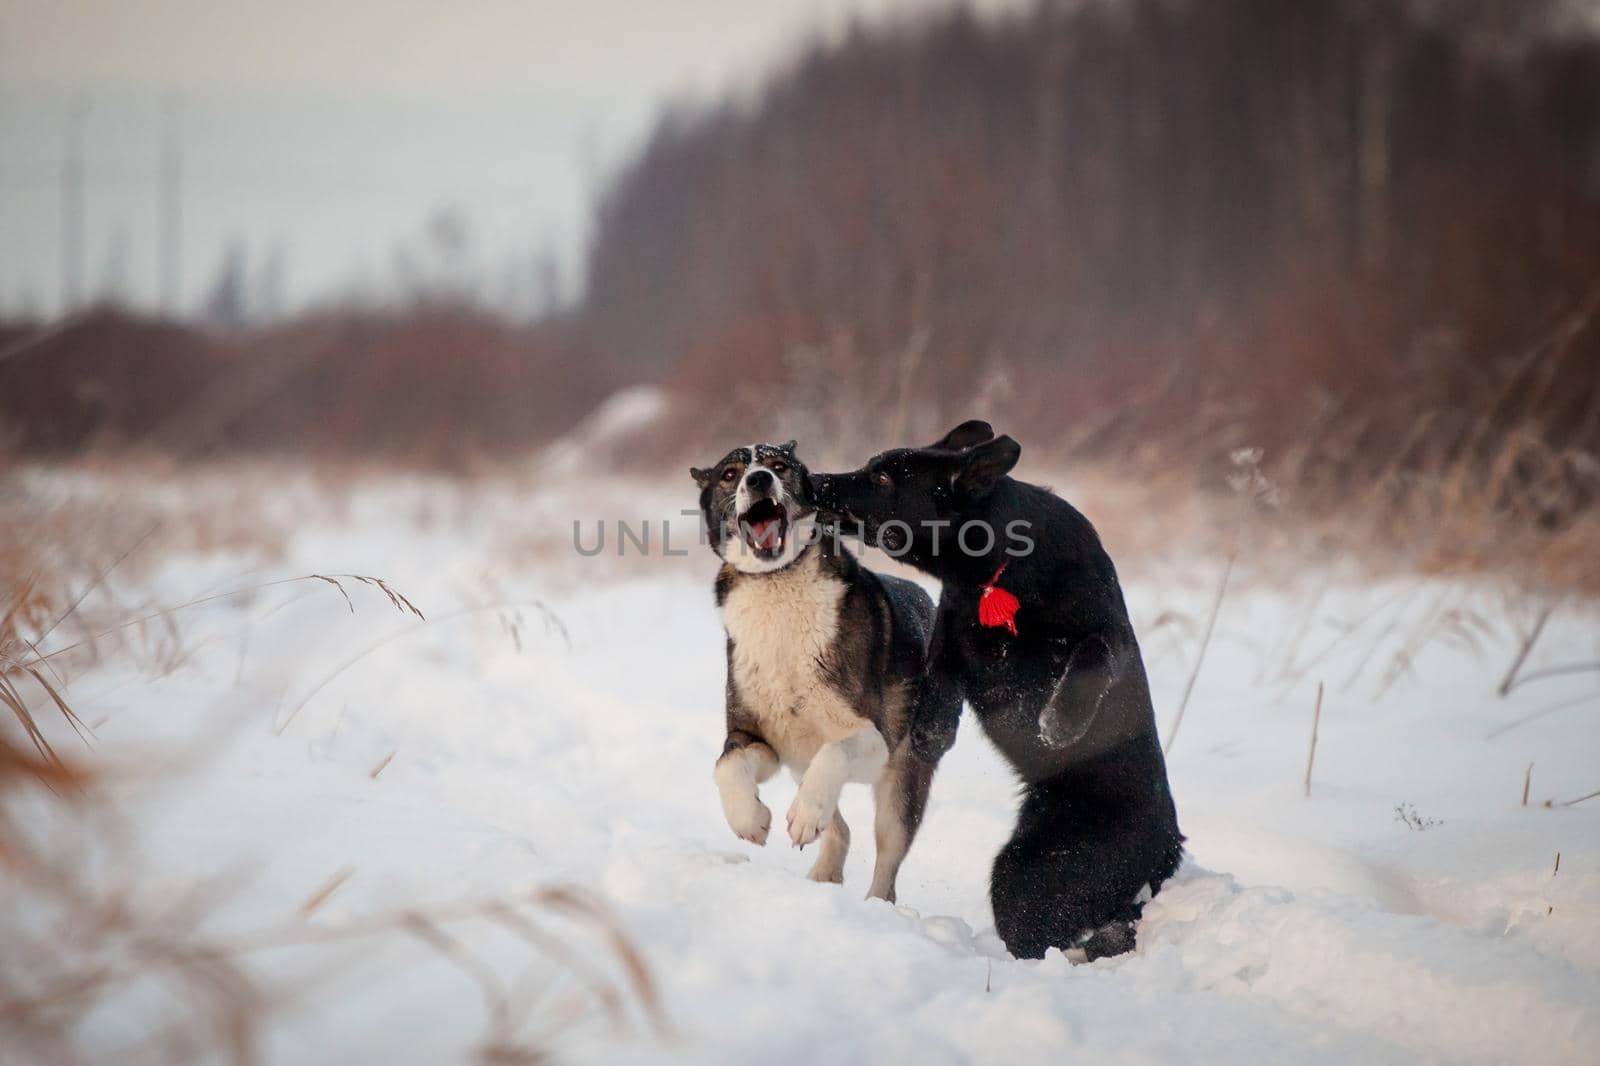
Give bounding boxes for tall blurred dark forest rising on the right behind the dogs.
[584,0,1600,480]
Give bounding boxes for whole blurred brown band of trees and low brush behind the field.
[0,0,1600,525]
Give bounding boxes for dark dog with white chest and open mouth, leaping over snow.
[690,440,938,901]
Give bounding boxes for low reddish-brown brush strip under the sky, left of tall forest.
[0,306,619,467]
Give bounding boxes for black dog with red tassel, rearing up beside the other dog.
[813,421,1184,959]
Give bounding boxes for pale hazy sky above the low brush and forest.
[0,0,1008,314]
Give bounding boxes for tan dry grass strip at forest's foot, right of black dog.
[1030,409,1600,602]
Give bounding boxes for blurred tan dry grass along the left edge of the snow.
[0,460,667,1063]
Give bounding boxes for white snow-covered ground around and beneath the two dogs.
[0,472,1600,1064]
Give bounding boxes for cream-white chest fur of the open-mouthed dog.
[722,559,861,767]
